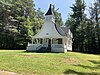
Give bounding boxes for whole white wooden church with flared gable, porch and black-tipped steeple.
[26,4,73,53]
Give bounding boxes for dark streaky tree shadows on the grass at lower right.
[63,60,100,75]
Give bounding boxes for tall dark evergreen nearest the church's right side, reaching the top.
[66,0,87,51]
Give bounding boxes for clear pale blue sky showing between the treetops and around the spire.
[34,0,94,22]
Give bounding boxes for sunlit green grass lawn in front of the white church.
[0,50,100,75]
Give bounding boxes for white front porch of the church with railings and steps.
[27,38,65,52]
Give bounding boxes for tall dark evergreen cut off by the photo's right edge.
[89,0,100,53]
